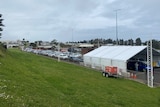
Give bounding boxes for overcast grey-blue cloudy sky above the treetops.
[0,0,160,42]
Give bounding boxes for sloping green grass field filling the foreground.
[0,49,160,107]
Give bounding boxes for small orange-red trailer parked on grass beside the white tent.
[102,66,118,77]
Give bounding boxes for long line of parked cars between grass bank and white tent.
[24,48,83,62]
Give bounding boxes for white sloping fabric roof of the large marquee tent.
[84,46,147,61]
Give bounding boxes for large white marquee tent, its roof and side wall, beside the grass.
[83,46,160,76]
